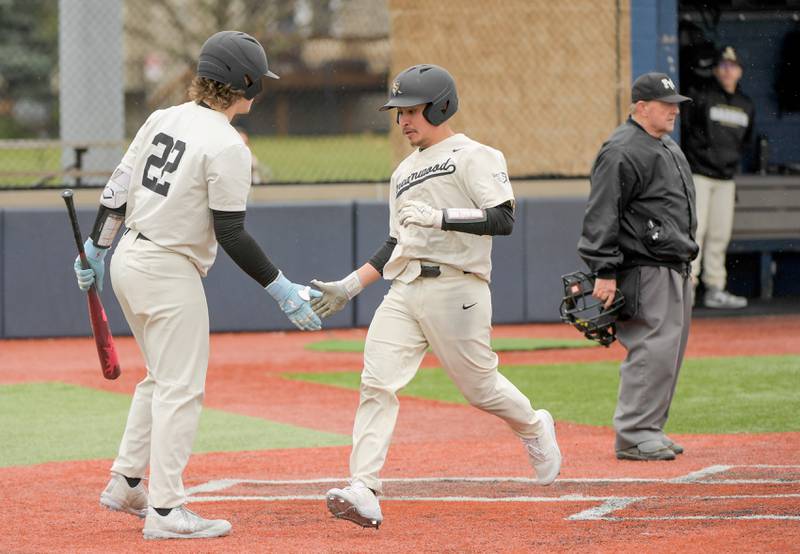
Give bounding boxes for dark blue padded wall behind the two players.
[0,198,585,338]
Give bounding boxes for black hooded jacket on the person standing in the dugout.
[681,79,755,180]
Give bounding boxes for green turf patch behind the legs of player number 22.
[0,383,351,467]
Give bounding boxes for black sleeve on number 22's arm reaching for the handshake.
[211,210,278,287]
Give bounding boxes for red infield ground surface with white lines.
[0,316,800,552]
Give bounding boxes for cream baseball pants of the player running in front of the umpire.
[350,265,541,492]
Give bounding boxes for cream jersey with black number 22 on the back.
[121,102,251,276]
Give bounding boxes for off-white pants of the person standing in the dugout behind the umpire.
[692,175,736,290]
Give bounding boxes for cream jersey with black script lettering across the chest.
[383,134,514,281]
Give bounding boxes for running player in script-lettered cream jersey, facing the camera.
[311,65,561,528]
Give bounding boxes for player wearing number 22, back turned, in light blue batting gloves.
[69,31,321,539]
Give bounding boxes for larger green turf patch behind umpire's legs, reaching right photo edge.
[287,356,800,434]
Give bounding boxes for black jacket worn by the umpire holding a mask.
[578,118,698,279]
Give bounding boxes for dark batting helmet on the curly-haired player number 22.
[197,31,280,100]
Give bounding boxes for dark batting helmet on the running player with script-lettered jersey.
[380,64,458,125]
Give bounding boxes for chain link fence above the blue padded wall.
[0,0,630,188]
